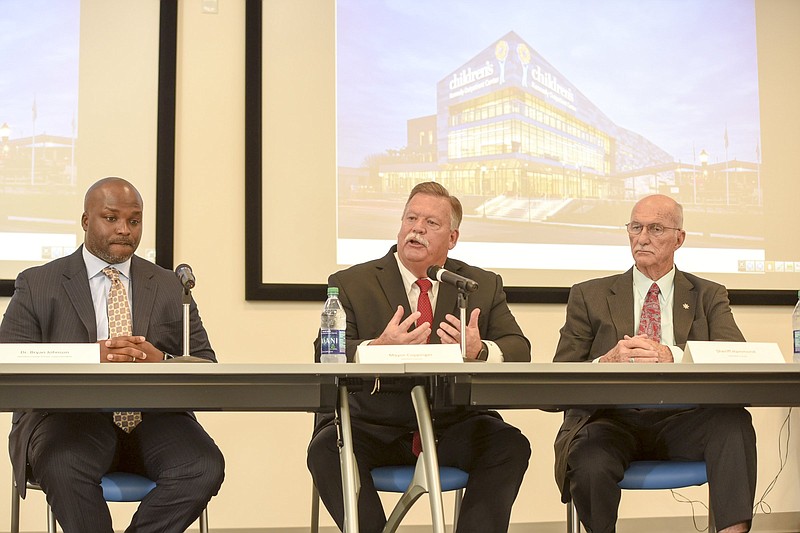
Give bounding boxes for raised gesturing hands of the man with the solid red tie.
[370,305,481,359]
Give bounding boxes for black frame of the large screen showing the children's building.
[245,0,797,306]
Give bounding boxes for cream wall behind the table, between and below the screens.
[0,0,800,531]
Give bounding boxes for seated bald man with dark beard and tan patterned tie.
[0,178,224,533]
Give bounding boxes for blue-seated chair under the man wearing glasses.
[567,461,716,533]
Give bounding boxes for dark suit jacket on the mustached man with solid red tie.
[315,246,531,442]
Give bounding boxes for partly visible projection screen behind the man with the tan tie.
[0,0,177,296]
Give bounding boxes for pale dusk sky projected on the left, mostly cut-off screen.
[0,0,80,139]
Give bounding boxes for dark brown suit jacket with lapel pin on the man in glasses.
[553,268,744,502]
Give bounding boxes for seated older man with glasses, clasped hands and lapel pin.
[554,195,756,533]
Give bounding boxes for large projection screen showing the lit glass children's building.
[247,0,800,304]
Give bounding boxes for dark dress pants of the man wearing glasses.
[567,408,756,533]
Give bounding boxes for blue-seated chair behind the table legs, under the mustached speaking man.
[311,465,469,533]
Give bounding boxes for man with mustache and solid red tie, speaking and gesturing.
[308,182,530,533]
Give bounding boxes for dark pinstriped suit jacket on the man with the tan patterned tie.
[0,246,216,496]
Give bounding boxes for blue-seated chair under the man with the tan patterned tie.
[11,472,208,533]
